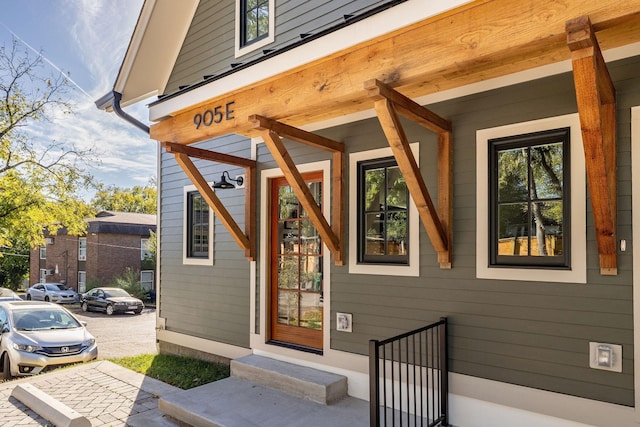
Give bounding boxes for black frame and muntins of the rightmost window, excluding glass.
[488,127,571,269]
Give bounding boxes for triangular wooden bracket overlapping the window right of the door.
[364,80,453,269]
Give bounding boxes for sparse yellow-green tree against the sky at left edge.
[0,40,95,251]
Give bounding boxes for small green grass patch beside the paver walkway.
[109,354,229,390]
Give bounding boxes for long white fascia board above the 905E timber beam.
[149,0,469,121]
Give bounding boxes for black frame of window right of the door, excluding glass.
[357,156,411,266]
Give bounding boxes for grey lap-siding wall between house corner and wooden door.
[159,135,250,347]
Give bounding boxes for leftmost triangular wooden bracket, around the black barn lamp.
[162,142,256,261]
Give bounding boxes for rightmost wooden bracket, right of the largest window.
[566,16,618,275]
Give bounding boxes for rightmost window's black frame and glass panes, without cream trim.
[489,128,571,268]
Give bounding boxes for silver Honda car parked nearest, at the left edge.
[0,301,98,380]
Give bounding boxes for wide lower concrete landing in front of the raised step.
[156,376,369,427]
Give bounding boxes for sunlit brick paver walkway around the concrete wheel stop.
[0,361,180,427]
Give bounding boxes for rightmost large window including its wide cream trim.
[476,114,586,283]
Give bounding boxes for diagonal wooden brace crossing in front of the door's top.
[262,129,343,265]
